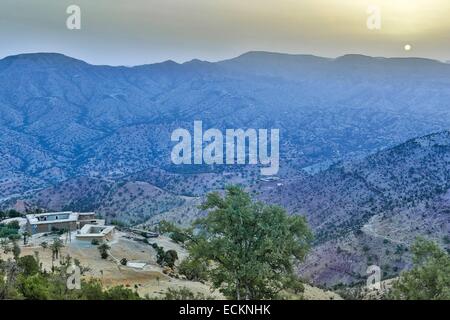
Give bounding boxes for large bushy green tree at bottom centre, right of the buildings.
[162,186,312,300]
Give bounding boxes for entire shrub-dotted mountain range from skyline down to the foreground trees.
[0,52,450,285]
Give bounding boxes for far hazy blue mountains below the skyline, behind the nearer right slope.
[0,52,450,208]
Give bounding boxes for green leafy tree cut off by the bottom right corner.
[388,238,450,300]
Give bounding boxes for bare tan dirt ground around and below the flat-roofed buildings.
[0,232,222,298]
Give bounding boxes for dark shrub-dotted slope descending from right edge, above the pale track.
[259,130,450,236]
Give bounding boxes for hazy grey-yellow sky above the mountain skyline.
[0,0,450,65]
